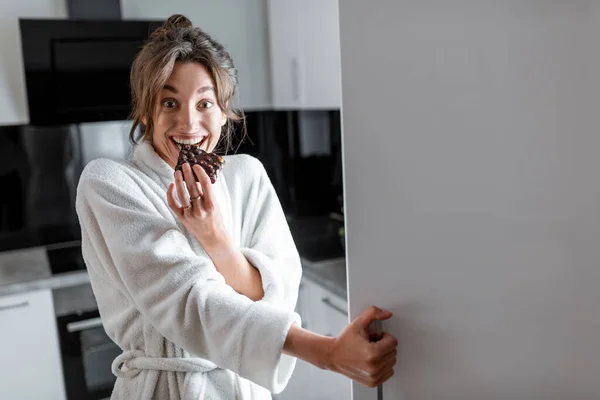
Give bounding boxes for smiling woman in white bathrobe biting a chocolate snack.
[77,15,397,399]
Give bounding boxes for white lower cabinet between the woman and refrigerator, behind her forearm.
[275,276,351,400]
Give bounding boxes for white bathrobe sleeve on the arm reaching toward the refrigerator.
[76,160,300,393]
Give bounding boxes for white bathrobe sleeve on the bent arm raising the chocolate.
[241,156,302,311]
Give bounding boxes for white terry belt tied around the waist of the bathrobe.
[112,350,219,378]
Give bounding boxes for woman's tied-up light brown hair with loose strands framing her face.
[129,14,245,149]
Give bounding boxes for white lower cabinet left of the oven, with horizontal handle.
[0,289,65,400]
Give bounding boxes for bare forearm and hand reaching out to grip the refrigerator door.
[283,306,398,387]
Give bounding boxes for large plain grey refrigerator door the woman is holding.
[339,0,600,400]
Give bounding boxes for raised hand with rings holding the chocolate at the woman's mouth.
[167,163,229,253]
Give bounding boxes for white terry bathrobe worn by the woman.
[76,142,301,400]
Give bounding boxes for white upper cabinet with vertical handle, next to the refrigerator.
[267,0,341,109]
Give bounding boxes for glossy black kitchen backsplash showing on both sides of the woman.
[0,111,342,251]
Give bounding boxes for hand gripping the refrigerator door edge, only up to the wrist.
[325,306,398,387]
